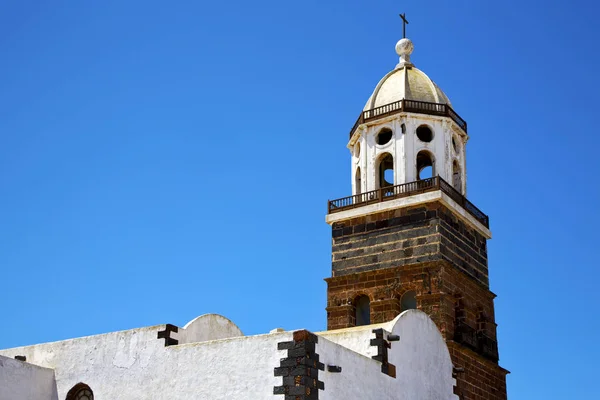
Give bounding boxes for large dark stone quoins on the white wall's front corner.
[273,330,325,400]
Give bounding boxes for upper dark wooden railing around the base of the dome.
[350,99,467,137]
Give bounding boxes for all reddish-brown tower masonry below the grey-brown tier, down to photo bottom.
[326,260,507,400]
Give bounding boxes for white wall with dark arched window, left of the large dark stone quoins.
[0,325,292,400]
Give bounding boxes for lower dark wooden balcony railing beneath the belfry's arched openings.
[327,176,490,228]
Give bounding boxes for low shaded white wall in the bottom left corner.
[0,356,58,400]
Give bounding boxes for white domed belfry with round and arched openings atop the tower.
[348,38,468,202]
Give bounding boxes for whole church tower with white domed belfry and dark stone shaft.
[326,30,508,400]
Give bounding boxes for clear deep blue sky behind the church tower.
[0,0,600,400]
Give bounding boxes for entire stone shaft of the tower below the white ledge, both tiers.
[326,202,508,400]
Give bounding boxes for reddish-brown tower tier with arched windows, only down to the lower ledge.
[326,260,496,340]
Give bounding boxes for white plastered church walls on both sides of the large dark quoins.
[0,310,456,400]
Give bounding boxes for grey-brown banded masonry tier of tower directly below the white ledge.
[332,202,488,286]
